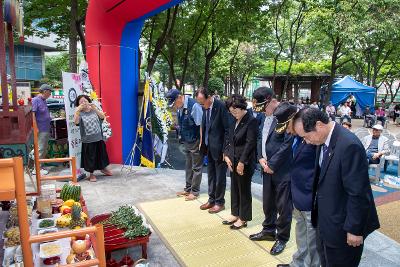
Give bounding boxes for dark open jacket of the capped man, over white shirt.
[257,118,293,181]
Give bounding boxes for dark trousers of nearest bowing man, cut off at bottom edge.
[317,229,364,267]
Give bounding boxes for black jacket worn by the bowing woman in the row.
[224,112,258,168]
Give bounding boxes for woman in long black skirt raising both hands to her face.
[74,95,112,182]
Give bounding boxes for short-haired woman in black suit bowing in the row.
[222,95,258,230]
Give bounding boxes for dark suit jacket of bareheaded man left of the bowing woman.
[201,98,233,160]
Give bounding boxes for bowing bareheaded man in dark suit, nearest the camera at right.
[294,108,379,267]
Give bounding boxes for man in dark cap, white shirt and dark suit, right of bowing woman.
[249,92,297,255]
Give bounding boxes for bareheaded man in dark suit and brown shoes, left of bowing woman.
[196,88,233,213]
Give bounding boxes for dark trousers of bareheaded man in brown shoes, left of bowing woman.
[207,152,227,205]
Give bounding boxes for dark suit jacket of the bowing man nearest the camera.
[312,124,380,248]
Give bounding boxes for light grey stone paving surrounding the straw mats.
[72,165,400,267]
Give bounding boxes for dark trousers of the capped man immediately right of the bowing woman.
[263,173,293,242]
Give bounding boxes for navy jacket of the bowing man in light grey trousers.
[291,138,317,211]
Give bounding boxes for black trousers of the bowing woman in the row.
[231,164,255,222]
